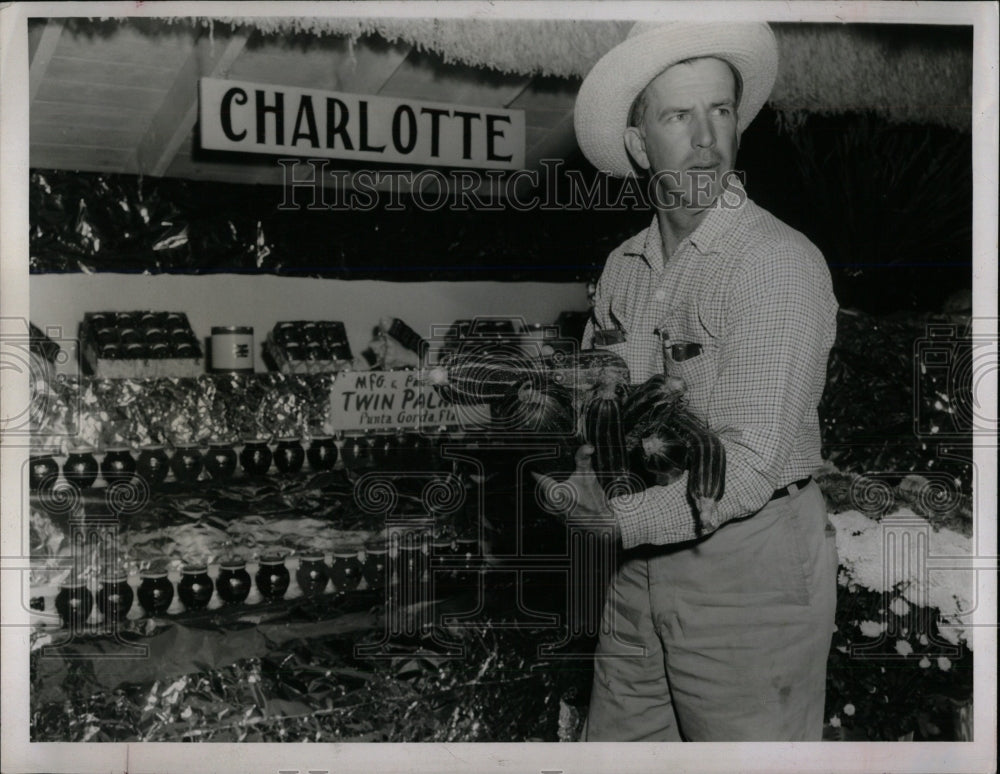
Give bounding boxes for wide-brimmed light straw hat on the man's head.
[574,22,778,177]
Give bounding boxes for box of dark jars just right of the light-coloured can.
[264,320,353,374]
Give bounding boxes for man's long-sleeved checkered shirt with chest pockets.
[583,185,837,548]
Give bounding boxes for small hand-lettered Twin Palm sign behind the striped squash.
[329,371,489,431]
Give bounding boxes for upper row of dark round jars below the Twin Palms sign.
[28,433,450,491]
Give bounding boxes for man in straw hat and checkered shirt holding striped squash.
[543,23,837,741]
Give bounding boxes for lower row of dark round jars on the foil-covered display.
[47,539,478,630]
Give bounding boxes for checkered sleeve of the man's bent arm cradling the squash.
[610,242,836,548]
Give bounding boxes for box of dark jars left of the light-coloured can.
[80,311,205,379]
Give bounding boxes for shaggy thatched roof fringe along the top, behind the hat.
[145,17,972,130]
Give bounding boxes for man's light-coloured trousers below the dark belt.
[583,482,837,742]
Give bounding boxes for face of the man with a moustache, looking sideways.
[625,58,739,210]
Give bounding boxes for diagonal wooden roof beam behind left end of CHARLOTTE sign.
[136,33,249,177]
